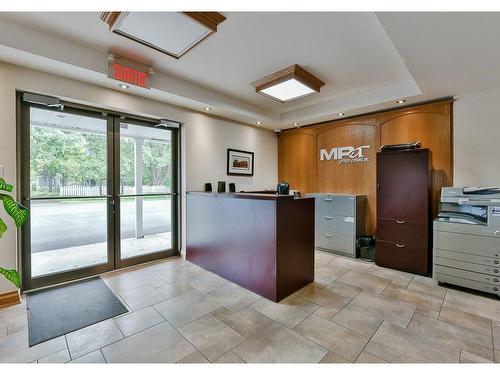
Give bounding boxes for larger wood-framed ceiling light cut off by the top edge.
[101,12,226,58]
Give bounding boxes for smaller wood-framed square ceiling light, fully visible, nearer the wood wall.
[252,64,325,103]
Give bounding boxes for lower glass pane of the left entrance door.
[30,198,108,277]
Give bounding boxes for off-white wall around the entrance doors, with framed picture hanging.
[0,62,278,294]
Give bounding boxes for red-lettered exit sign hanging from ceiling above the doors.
[108,55,152,89]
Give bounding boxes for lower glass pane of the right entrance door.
[120,196,172,259]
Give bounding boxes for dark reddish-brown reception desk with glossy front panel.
[186,192,314,302]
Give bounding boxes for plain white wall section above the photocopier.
[453,87,500,186]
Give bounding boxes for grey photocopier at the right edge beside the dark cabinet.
[433,187,500,297]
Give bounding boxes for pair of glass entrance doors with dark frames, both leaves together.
[20,97,177,290]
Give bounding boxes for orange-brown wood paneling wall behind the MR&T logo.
[278,100,453,233]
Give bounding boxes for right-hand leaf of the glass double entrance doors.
[115,120,177,265]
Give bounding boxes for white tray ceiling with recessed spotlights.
[0,12,500,128]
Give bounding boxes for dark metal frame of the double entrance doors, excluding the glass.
[16,91,181,292]
